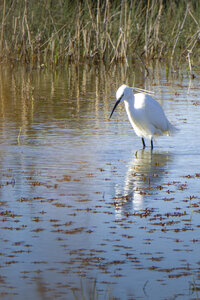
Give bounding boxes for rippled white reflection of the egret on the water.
[115,150,172,218]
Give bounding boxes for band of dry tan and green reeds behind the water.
[0,0,200,69]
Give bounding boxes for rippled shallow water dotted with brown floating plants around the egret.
[0,65,200,300]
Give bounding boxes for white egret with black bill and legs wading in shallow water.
[109,84,177,150]
